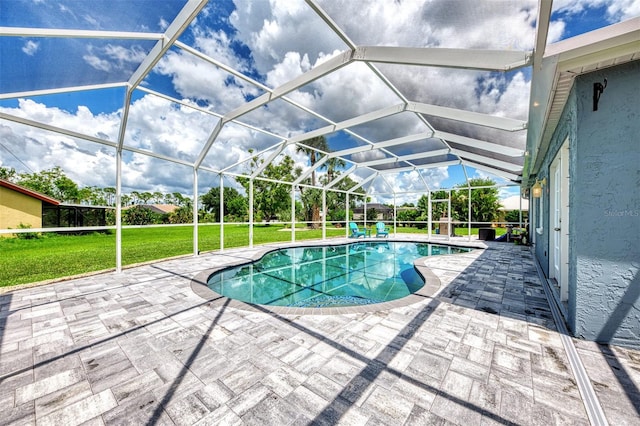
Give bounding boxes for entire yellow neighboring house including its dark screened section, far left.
[0,179,112,235]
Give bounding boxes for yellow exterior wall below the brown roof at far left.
[0,187,42,236]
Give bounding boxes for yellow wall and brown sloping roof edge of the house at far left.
[0,179,60,231]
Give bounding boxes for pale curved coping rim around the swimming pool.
[191,238,487,315]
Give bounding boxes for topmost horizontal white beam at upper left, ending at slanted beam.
[0,27,163,40]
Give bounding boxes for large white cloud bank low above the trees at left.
[0,95,274,193]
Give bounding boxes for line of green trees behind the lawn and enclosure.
[0,136,510,228]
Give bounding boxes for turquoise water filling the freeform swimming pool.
[207,241,469,307]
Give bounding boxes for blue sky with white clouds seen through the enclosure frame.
[0,0,640,203]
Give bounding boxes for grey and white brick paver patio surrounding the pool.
[0,239,640,425]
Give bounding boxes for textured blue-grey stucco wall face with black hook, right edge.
[569,61,640,348]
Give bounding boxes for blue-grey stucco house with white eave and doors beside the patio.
[523,29,640,348]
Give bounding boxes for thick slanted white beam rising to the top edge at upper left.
[129,0,208,89]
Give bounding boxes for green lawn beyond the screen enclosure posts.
[0,224,505,287]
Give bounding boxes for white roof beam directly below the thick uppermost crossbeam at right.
[407,102,527,132]
